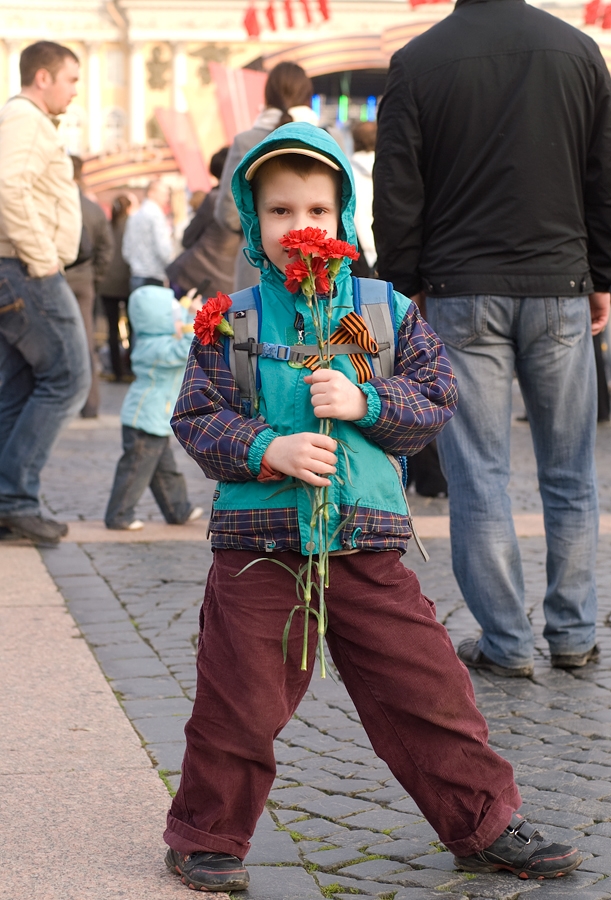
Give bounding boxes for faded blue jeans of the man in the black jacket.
[427,295,598,666]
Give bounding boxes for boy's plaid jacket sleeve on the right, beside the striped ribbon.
[361,303,458,456]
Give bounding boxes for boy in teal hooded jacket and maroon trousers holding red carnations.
[164,125,581,890]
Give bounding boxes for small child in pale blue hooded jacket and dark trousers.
[105,285,203,531]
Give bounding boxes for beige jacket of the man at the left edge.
[0,96,81,278]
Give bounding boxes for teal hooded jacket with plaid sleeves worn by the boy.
[172,124,456,555]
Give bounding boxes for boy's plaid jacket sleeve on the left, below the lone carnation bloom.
[171,338,273,481]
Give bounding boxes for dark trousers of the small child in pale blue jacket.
[104,425,192,528]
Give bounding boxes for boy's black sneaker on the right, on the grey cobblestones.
[454,813,583,879]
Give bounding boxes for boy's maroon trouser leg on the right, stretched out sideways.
[327,551,521,856]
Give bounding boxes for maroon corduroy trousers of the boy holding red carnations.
[164,550,521,858]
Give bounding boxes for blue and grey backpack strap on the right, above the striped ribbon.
[352,277,397,378]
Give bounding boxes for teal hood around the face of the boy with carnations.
[231,122,357,280]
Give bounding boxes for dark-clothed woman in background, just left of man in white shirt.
[100,194,137,381]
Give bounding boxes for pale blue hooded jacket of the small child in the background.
[121,285,192,437]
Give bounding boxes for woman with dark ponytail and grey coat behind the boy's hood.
[214,62,318,291]
